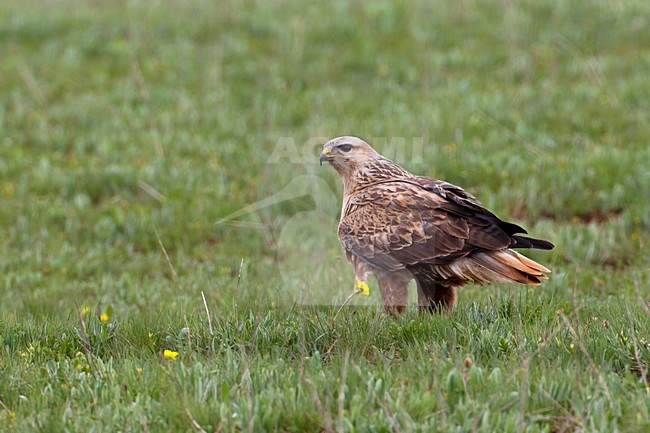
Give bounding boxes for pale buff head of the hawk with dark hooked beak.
[319,136,379,174]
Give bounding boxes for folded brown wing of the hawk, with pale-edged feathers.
[339,181,512,271]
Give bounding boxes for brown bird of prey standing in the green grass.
[320,137,553,313]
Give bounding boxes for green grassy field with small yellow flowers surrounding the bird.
[0,0,650,432]
